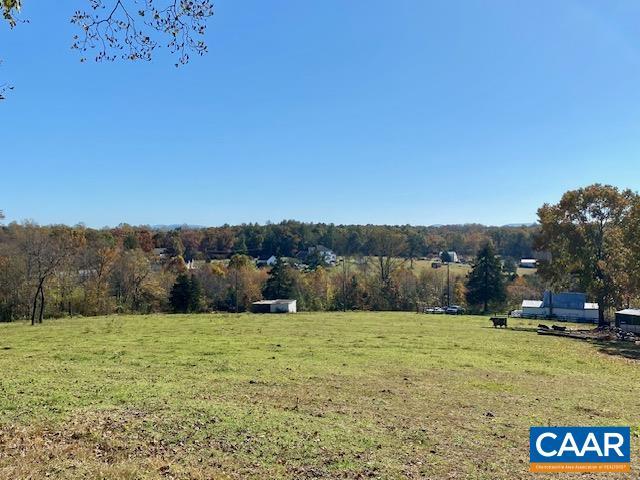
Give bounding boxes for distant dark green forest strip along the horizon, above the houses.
[122,220,538,261]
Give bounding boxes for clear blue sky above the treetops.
[0,0,640,226]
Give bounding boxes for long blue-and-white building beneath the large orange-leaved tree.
[522,291,599,323]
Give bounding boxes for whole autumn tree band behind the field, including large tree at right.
[6,184,640,323]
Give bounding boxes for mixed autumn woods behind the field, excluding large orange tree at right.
[0,221,537,323]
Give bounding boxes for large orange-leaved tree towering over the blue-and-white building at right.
[535,184,635,324]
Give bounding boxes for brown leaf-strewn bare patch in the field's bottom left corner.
[0,410,241,480]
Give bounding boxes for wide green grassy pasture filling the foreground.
[0,313,640,479]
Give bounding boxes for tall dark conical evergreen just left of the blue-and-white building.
[467,243,507,313]
